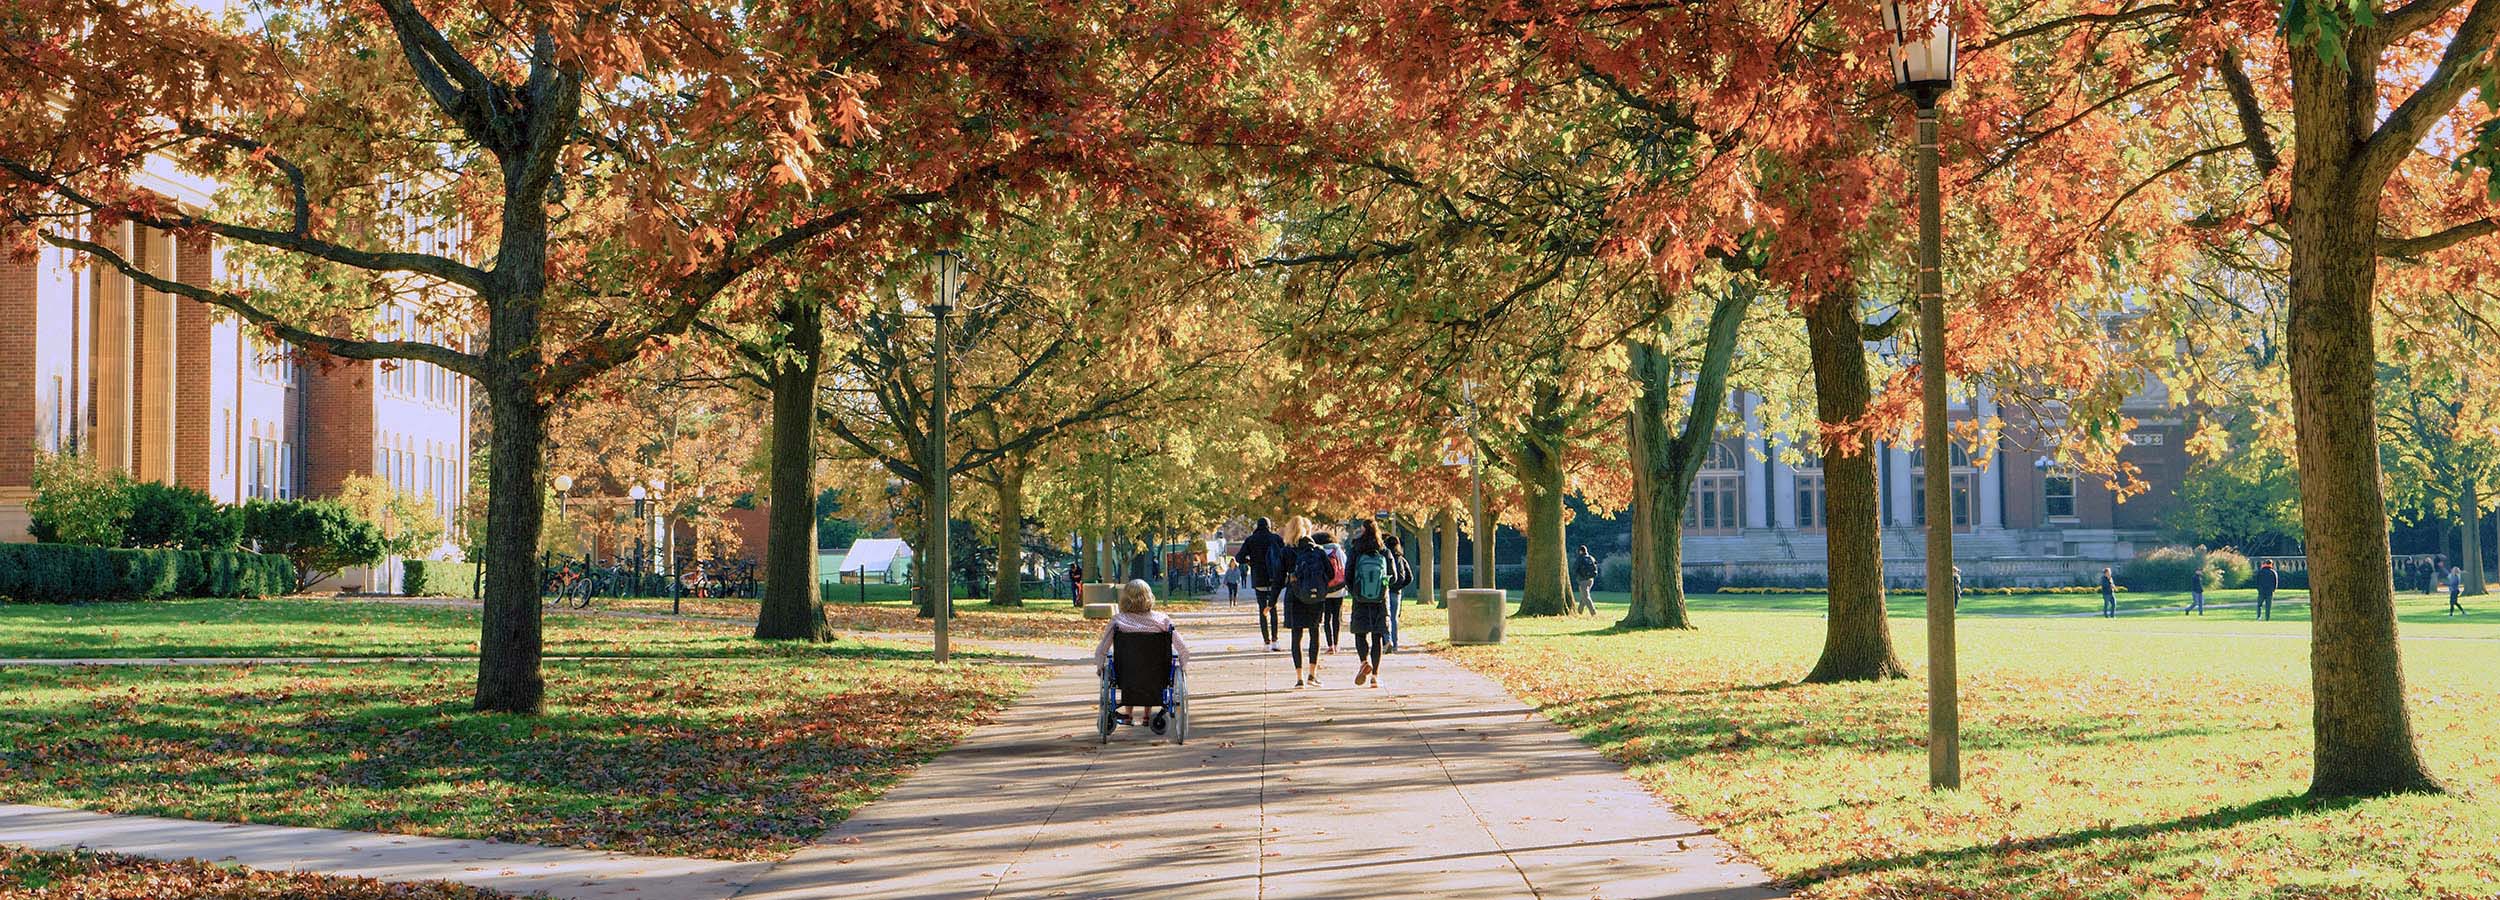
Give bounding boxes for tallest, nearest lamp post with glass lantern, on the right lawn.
[1883,0,1963,790]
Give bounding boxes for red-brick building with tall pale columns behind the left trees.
[0,173,470,588]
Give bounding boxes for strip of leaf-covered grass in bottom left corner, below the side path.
[0,848,510,900]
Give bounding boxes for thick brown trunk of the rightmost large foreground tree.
[2285,53,2440,798]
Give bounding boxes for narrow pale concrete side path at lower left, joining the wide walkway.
[0,805,773,900]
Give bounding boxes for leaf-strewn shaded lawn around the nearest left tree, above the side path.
[0,650,1040,860]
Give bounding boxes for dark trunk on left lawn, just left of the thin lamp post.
[755,293,830,640]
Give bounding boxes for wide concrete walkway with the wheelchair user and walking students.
[740,613,1783,900]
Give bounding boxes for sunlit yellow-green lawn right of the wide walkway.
[1405,593,2500,900]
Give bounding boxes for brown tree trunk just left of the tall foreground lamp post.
[1805,293,1910,685]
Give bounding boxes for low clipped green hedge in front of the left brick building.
[0,543,295,603]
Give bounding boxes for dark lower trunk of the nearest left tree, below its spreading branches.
[473,375,548,715]
